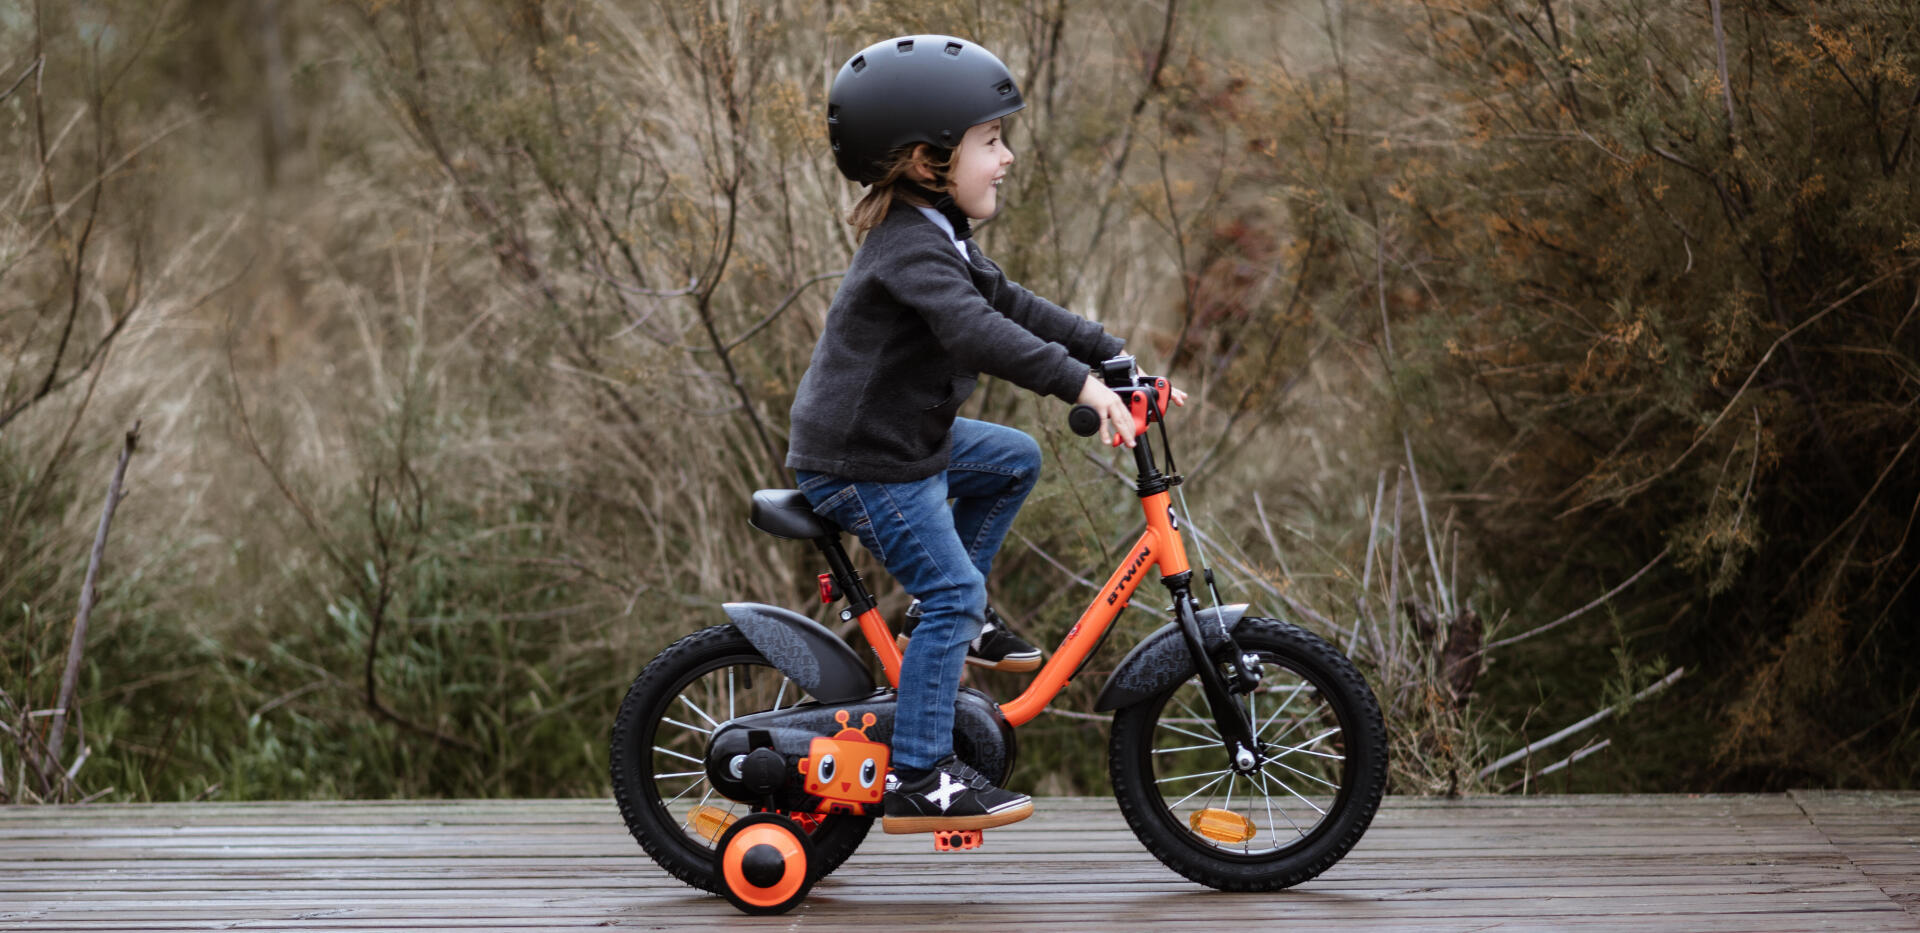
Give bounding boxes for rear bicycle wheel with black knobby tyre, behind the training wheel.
[611,624,874,893]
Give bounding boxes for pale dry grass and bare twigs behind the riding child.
[0,0,1781,801]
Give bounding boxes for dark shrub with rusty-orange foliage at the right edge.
[1363,0,1920,787]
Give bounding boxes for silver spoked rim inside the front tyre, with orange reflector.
[1148,653,1346,858]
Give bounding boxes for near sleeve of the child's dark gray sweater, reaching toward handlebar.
[885,240,1098,401]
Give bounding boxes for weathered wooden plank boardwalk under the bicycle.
[0,793,1920,933]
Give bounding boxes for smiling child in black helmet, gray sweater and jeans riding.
[787,36,1133,833]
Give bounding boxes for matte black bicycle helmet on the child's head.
[828,36,1027,184]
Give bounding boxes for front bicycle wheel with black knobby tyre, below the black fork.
[1108,618,1386,891]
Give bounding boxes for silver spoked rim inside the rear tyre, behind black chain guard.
[641,662,804,849]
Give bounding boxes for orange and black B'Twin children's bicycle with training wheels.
[612,357,1386,914]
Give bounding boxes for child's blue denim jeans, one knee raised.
[795,419,1041,770]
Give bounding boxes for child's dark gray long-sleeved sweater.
[787,202,1125,482]
